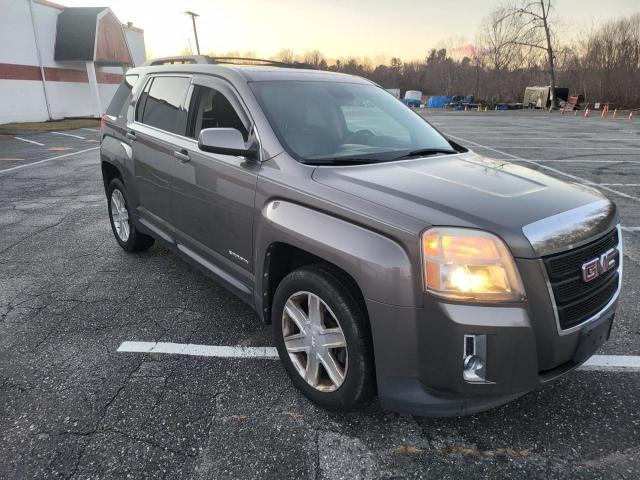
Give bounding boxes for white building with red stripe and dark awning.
[0,0,145,124]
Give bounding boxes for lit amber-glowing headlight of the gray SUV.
[422,227,524,302]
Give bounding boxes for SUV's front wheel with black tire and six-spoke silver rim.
[272,266,375,411]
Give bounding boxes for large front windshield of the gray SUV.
[251,81,456,164]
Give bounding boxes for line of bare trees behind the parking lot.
[205,0,640,108]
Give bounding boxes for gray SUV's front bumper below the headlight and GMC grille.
[367,282,617,416]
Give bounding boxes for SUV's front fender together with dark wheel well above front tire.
[255,200,417,322]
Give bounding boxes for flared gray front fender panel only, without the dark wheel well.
[255,200,419,306]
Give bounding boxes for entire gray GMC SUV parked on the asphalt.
[100,57,622,416]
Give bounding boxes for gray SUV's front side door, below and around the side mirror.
[172,76,260,293]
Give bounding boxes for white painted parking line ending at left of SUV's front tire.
[118,342,278,360]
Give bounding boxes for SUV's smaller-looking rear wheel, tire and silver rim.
[107,178,155,252]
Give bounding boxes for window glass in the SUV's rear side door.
[136,77,190,135]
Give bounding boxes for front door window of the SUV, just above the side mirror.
[188,85,249,141]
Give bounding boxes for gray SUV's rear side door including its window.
[126,75,191,241]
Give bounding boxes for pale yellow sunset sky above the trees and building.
[57,0,640,60]
